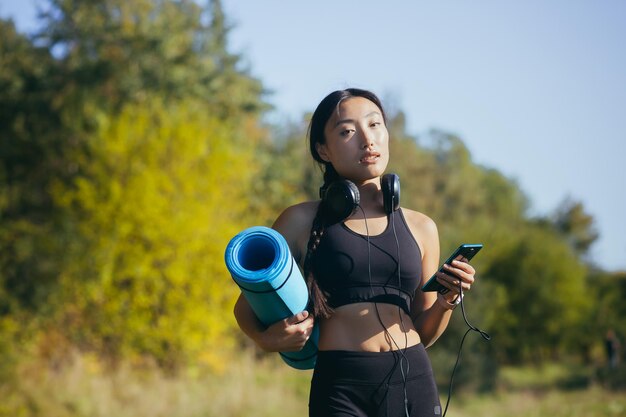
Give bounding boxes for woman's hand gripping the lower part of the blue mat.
[258,310,314,352]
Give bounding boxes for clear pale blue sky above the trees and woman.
[0,0,626,270]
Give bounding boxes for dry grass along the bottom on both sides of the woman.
[0,354,626,417]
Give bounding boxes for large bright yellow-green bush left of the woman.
[54,100,254,367]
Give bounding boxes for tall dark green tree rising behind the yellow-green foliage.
[0,0,266,313]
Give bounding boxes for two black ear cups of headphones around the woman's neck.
[320,174,400,224]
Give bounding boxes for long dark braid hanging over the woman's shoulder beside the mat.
[303,163,339,318]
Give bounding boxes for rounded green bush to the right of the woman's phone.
[483,226,592,362]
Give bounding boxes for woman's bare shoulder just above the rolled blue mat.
[272,201,319,261]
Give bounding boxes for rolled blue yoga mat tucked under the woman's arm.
[225,226,319,369]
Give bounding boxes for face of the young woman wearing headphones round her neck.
[316,97,389,183]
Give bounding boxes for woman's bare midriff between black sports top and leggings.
[318,303,420,352]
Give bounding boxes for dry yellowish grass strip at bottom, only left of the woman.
[0,355,310,417]
